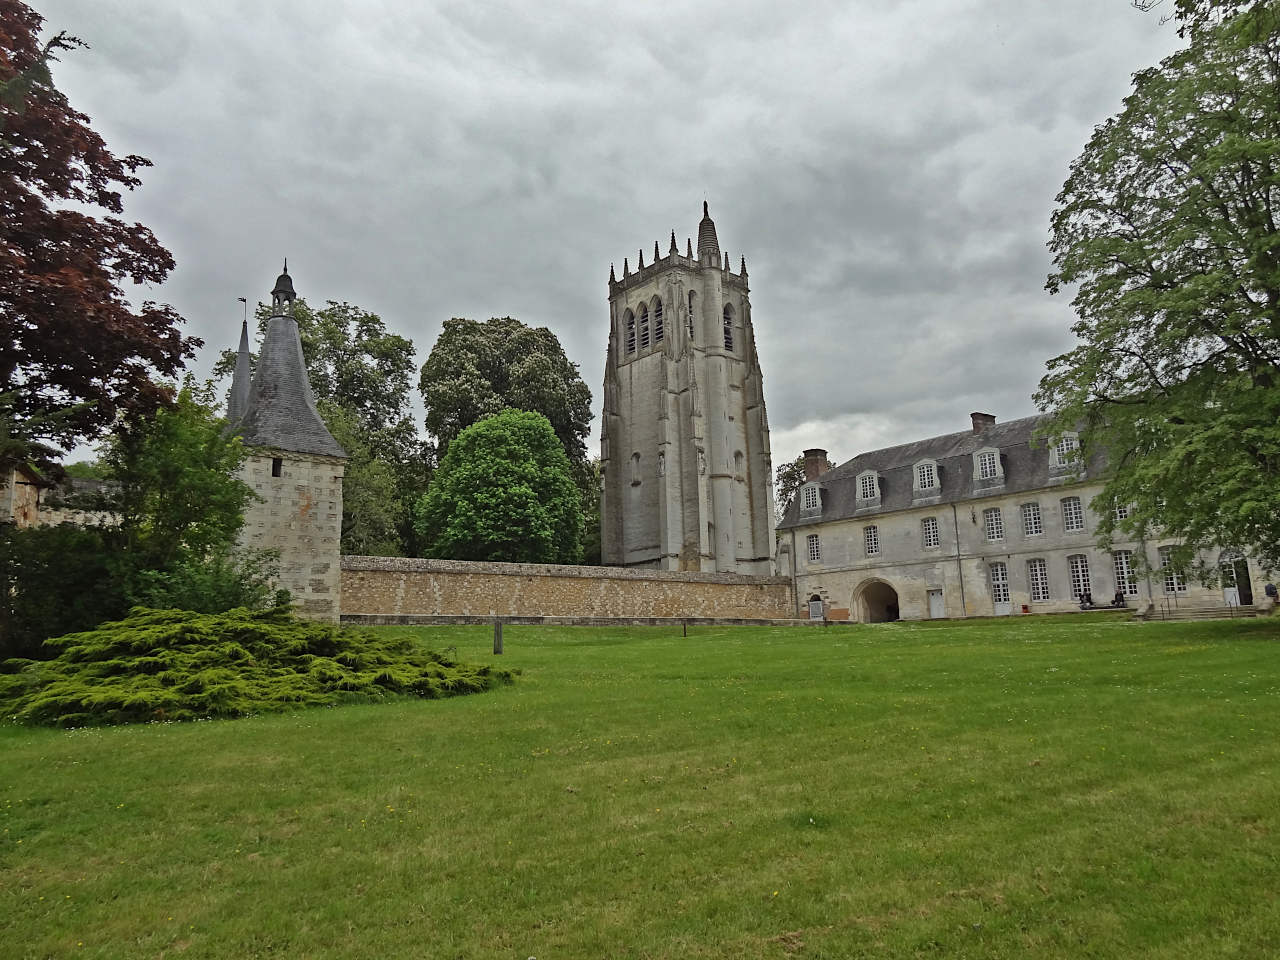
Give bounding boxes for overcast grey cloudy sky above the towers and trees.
[52,0,1179,463]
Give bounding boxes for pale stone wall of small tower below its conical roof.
[239,448,346,620]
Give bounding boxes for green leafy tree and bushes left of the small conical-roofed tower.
[0,378,274,659]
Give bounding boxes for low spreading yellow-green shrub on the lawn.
[0,607,512,726]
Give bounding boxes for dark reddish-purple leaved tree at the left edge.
[0,0,200,471]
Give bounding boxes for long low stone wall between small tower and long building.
[342,557,795,620]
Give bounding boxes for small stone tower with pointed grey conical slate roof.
[227,261,347,621]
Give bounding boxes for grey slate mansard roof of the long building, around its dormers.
[778,416,1101,530]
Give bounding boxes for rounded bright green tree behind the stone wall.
[415,410,582,563]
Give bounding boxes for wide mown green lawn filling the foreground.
[0,617,1280,960]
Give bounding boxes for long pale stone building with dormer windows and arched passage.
[778,415,1265,622]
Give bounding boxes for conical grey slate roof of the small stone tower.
[237,271,347,458]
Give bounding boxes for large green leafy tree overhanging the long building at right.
[1036,3,1280,564]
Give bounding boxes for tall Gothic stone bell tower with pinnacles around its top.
[600,204,773,575]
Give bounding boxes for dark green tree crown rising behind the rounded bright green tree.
[419,316,593,471]
